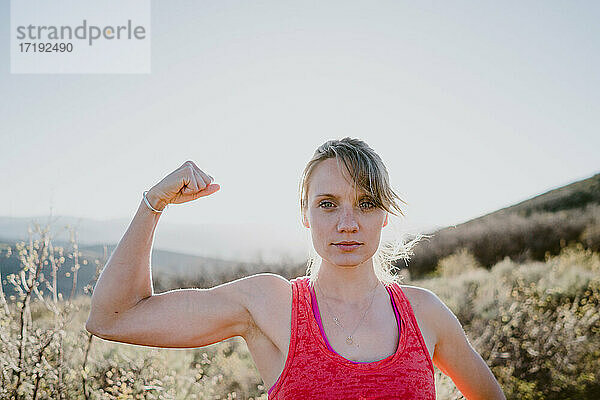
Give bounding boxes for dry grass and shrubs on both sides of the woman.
[0,223,600,399]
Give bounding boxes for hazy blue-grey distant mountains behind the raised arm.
[0,216,316,302]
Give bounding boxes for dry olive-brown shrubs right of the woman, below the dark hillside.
[416,244,600,400]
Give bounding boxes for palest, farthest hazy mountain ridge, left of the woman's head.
[0,216,310,262]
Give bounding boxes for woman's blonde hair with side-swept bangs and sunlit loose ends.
[299,137,427,286]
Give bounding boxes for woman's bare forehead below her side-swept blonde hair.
[308,158,364,197]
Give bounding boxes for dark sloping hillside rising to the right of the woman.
[408,174,600,277]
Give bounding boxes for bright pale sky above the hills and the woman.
[0,0,600,253]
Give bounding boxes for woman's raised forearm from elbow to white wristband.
[88,192,164,327]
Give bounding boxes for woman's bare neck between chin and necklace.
[316,259,380,306]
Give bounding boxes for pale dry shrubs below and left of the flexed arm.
[0,226,266,399]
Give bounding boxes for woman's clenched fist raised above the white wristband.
[146,161,221,210]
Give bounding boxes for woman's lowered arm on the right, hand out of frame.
[423,289,505,400]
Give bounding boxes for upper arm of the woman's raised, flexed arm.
[86,273,283,348]
